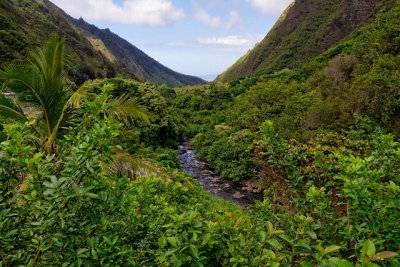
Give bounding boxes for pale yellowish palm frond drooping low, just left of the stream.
[101,153,169,180]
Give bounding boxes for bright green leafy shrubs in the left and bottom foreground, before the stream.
[0,92,399,266]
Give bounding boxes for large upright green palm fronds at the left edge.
[0,35,72,135]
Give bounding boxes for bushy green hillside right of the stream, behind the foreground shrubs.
[174,0,400,180]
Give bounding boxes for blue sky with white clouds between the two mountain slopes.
[51,0,292,80]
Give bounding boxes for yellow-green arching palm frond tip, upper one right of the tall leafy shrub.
[108,94,151,123]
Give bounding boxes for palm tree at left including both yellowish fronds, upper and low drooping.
[0,35,165,178]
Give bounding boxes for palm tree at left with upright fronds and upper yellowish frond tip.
[0,35,148,154]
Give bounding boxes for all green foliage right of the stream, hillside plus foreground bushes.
[165,3,400,266]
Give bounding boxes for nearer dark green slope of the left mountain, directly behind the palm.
[0,0,123,83]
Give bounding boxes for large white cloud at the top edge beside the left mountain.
[51,0,185,26]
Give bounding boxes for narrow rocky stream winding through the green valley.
[178,139,263,207]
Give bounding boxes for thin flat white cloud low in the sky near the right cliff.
[197,34,262,48]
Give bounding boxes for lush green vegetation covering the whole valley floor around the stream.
[0,3,400,266]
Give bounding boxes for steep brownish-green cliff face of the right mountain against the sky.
[217,0,388,81]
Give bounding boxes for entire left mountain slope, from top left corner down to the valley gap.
[0,0,205,86]
